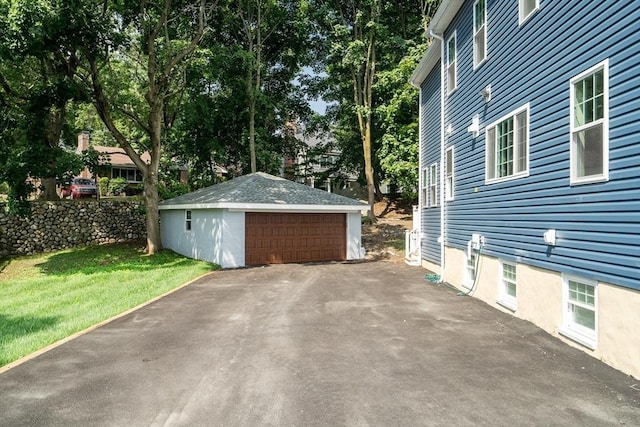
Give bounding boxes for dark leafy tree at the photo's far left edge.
[0,0,84,211]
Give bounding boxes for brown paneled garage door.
[245,212,347,265]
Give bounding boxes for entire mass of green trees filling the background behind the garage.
[0,0,438,237]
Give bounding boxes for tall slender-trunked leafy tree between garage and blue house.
[313,0,438,214]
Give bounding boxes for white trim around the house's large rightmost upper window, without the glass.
[569,59,609,185]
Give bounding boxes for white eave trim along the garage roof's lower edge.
[158,203,368,212]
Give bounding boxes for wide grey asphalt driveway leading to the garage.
[0,262,640,426]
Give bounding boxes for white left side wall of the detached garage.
[160,209,223,265]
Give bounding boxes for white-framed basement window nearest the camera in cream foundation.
[560,275,598,349]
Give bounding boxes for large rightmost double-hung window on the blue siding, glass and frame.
[570,60,609,184]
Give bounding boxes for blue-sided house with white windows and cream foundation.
[411,0,640,378]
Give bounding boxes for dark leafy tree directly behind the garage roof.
[170,0,313,182]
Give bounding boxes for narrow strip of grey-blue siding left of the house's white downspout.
[420,61,441,265]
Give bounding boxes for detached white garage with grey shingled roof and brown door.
[160,172,367,268]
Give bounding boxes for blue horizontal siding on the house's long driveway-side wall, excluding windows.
[436,0,640,290]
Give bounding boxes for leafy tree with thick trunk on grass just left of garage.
[83,0,216,254]
